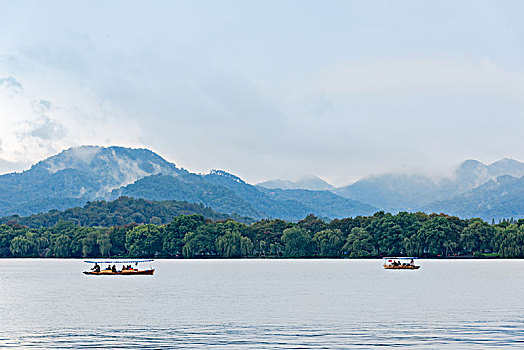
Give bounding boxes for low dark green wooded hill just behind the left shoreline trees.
[0,197,253,228]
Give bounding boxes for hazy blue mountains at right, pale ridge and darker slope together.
[259,158,524,220]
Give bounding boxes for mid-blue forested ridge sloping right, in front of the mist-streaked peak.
[112,170,377,220]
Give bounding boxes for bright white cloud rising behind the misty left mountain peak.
[0,77,141,172]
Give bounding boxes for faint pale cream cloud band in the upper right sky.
[312,57,524,98]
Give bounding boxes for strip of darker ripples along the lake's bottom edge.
[4,323,524,349]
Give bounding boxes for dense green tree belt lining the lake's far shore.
[0,212,524,258]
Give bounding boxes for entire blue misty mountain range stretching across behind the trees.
[0,146,524,220]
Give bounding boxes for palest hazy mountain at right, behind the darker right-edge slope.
[333,159,524,212]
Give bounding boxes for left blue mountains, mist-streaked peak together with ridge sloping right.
[0,146,377,220]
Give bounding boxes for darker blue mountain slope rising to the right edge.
[423,175,524,221]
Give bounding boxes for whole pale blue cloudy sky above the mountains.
[0,0,524,185]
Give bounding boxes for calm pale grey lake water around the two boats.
[0,259,524,349]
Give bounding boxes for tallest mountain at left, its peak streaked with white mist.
[0,146,183,216]
